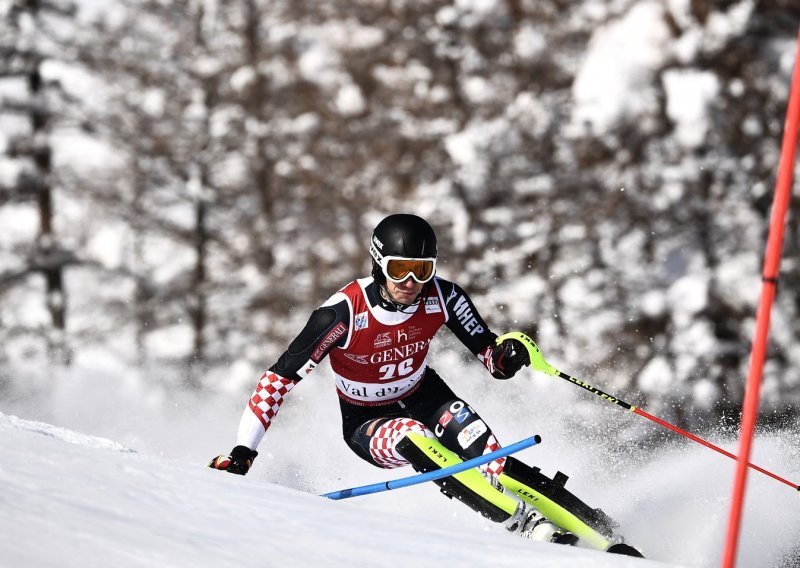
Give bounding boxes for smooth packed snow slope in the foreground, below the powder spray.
[0,414,663,568]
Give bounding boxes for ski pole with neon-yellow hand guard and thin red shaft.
[497,331,800,492]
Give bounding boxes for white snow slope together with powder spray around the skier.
[0,367,800,568]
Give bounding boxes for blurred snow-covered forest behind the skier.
[0,0,800,425]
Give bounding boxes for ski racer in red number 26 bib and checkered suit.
[209,214,644,553]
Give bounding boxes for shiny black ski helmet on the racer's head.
[369,213,437,285]
